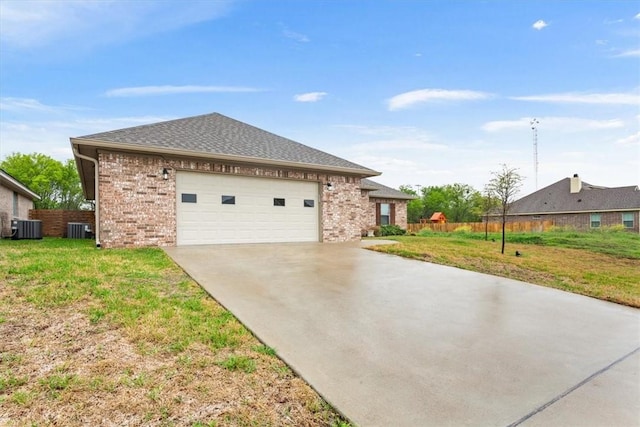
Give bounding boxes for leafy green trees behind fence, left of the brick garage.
[0,153,85,210]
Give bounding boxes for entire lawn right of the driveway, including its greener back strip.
[369,231,640,307]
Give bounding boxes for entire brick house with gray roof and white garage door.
[71,113,406,248]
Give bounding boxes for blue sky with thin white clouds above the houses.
[0,0,640,195]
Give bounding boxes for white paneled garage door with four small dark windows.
[176,171,320,245]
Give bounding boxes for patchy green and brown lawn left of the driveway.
[0,239,347,426]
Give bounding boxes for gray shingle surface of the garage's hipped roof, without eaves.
[73,113,379,176]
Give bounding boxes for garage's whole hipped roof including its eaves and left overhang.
[71,113,380,201]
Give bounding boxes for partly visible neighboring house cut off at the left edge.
[0,169,40,237]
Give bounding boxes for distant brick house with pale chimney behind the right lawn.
[508,174,640,233]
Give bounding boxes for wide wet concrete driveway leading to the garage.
[166,243,640,426]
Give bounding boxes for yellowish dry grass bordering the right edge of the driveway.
[369,233,640,307]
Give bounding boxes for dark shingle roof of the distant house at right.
[509,177,640,215]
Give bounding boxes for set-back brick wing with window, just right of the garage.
[360,179,415,230]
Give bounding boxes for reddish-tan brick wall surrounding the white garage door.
[98,152,370,248]
